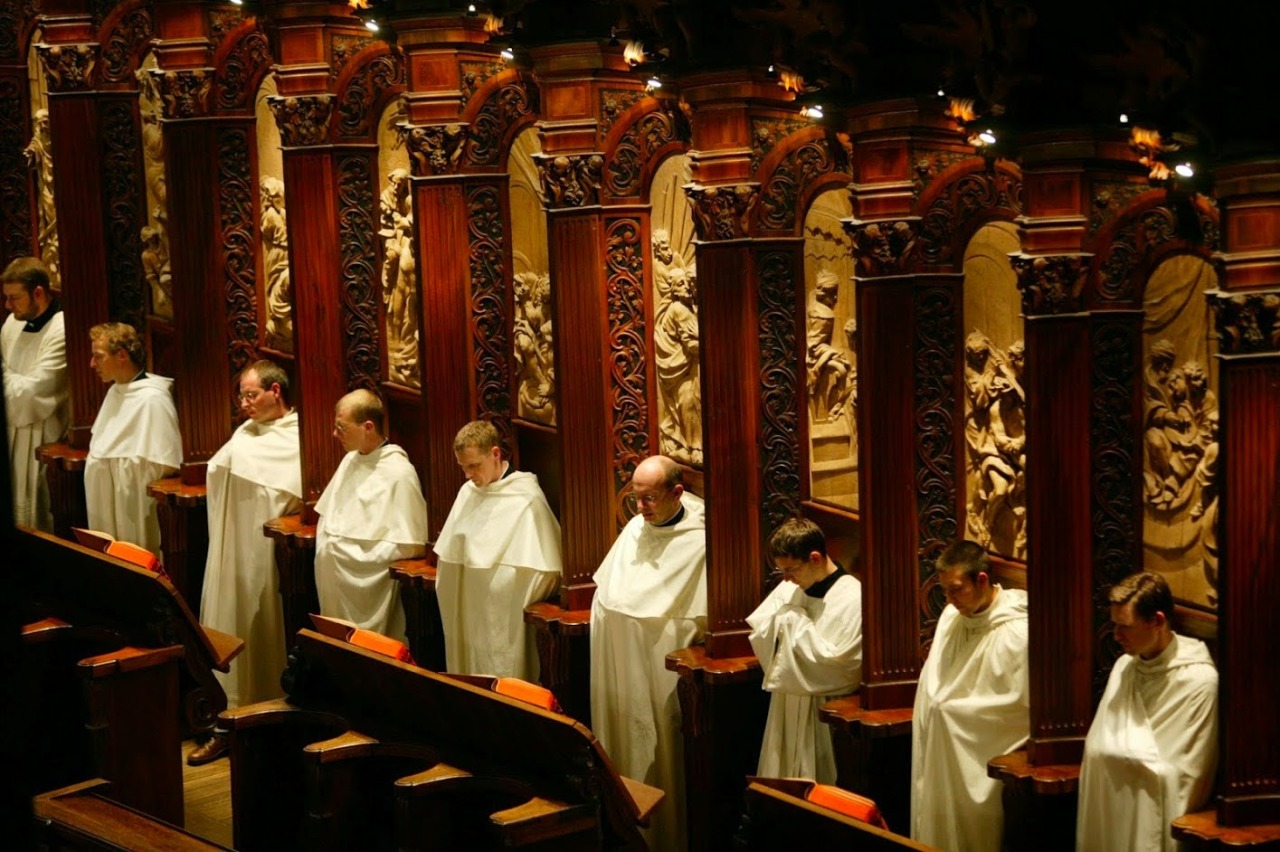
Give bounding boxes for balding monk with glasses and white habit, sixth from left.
[591,455,707,851]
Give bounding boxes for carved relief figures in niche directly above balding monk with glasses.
[650,229,703,466]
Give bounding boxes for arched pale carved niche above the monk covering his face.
[804,188,858,512]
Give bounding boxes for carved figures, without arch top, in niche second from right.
[964,331,1027,559]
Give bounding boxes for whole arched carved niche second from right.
[961,221,1027,560]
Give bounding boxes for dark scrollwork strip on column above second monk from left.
[100,97,146,329]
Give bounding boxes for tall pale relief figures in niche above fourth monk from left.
[378,169,422,388]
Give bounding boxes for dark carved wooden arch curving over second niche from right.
[916,168,1023,265]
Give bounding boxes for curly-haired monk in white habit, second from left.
[84,322,182,556]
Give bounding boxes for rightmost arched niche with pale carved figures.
[1142,255,1219,610]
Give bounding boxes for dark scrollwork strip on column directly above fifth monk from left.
[467,183,511,434]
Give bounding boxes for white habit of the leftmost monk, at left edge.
[0,308,68,531]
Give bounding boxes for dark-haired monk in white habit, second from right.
[911,541,1030,852]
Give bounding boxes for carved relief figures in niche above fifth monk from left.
[512,272,556,425]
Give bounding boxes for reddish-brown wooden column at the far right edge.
[1174,159,1280,848]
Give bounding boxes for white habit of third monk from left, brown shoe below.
[200,411,302,707]
